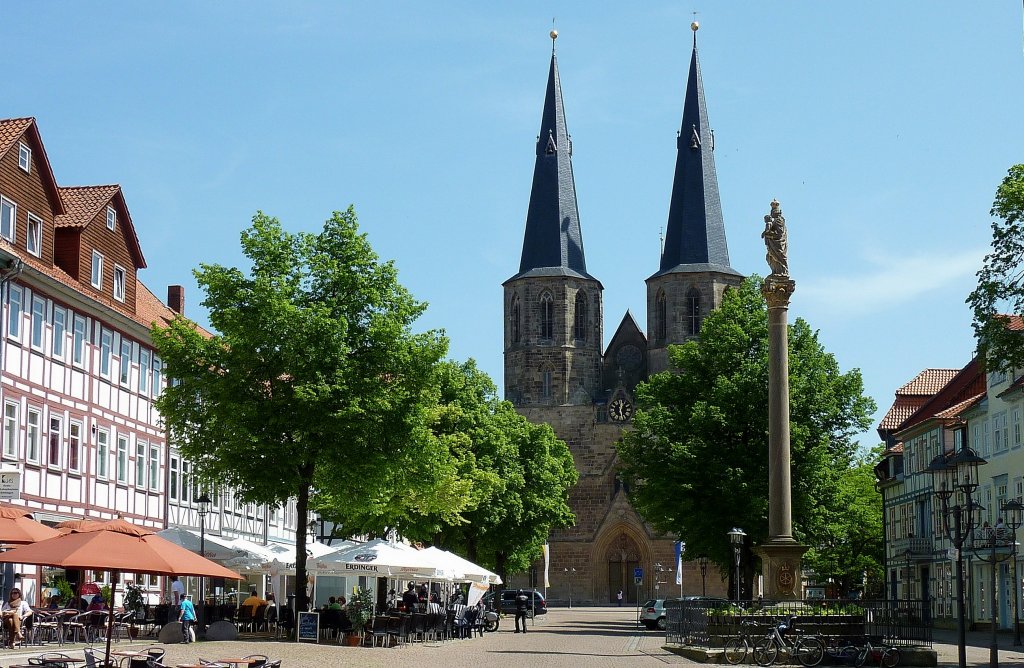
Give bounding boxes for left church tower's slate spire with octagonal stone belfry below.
[503,31,603,409]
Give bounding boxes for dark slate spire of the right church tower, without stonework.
[655,29,739,276]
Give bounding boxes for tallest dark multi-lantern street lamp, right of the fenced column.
[928,442,986,668]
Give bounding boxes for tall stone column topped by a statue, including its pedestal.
[754,201,807,599]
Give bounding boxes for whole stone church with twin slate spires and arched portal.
[503,28,744,606]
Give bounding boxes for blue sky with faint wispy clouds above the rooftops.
[3,0,1024,444]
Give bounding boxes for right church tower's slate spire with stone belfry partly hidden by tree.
[647,23,743,373]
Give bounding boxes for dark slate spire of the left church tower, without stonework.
[513,33,592,279]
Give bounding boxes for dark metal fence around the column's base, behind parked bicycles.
[665,598,932,648]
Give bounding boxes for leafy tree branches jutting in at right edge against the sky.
[967,165,1024,370]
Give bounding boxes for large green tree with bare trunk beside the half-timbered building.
[153,208,452,609]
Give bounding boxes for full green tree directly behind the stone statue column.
[618,277,874,594]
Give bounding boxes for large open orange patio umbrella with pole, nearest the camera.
[0,518,242,662]
